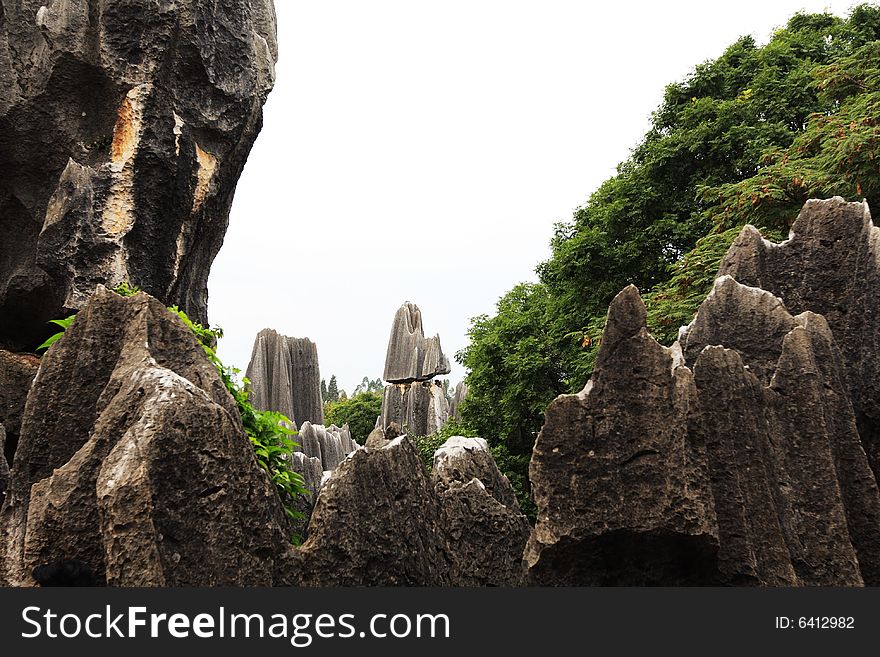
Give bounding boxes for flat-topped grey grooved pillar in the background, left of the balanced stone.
[247,329,324,426]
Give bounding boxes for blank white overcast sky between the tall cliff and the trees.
[209,0,854,393]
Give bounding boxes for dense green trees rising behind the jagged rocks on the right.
[457,5,880,466]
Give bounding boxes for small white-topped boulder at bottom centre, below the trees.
[432,436,530,586]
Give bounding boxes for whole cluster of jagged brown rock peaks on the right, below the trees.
[525,198,880,586]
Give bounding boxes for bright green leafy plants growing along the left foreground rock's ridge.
[37,282,310,544]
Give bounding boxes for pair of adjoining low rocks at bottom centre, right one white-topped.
[278,429,529,586]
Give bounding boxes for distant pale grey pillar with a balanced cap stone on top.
[376,302,450,436]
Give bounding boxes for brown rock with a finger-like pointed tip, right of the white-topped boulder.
[525,286,718,586]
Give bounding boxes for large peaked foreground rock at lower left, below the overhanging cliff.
[0,287,287,586]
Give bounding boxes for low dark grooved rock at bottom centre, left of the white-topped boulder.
[279,436,452,586]
